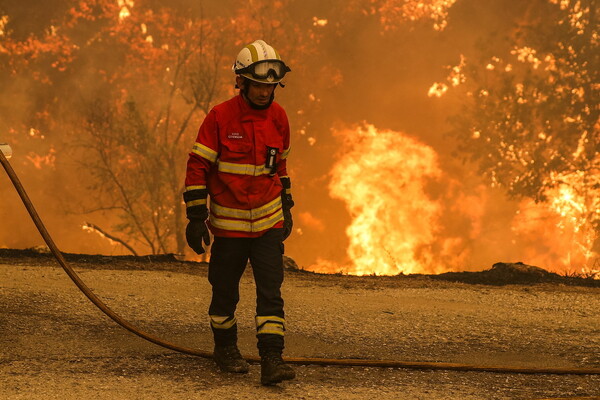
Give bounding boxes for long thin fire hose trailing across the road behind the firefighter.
[0,144,600,375]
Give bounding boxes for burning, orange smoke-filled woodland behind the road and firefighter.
[0,0,600,275]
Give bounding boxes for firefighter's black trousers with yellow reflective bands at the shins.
[208,229,284,349]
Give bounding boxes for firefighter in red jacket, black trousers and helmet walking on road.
[183,40,295,385]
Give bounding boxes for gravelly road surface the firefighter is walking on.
[0,254,600,400]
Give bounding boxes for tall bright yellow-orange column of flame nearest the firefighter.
[309,125,441,275]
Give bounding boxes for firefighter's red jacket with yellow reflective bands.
[185,95,290,237]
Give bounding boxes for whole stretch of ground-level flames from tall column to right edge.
[310,125,600,276]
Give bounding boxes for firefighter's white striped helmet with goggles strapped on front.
[233,40,291,84]
